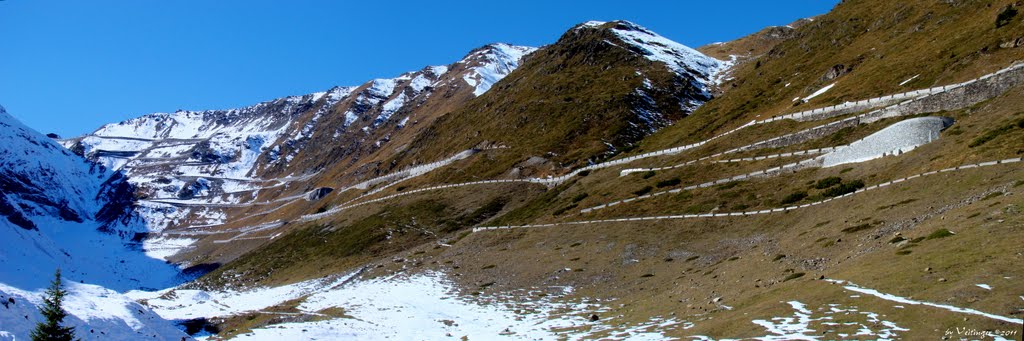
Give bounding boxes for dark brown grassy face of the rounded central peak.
[395,24,708,175]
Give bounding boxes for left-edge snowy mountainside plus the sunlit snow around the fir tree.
[0,104,190,340]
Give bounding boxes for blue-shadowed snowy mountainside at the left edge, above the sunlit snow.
[0,105,178,289]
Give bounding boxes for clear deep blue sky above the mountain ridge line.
[0,0,838,136]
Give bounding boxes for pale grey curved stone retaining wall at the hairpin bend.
[821,117,953,167]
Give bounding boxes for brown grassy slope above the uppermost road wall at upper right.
[636,0,1024,153]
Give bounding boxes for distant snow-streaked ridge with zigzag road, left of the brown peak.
[62,43,536,249]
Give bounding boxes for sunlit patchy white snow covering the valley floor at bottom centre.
[128,272,693,340]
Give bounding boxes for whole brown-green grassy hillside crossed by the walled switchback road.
[193,1,1024,338]
